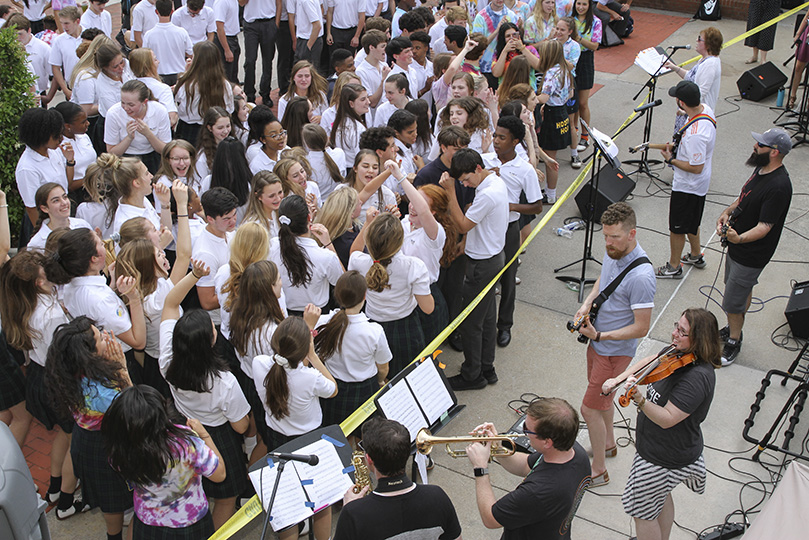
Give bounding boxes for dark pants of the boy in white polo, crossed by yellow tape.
[461,251,505,381]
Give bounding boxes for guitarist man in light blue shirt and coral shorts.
[576,202,656,487]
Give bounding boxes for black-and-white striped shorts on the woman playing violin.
[621,453,706,521]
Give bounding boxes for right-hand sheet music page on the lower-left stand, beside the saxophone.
[295,439,354,512]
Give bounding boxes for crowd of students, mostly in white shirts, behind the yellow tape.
[0,0,620,540]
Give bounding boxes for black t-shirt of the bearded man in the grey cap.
[728,165,792,268]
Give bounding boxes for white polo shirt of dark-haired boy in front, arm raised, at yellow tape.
[465,173,508,260]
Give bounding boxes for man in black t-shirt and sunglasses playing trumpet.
[466,398,590,540]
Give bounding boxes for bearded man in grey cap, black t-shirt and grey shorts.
[716,128,792,366]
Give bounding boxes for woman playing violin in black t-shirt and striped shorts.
[603,308,722,540]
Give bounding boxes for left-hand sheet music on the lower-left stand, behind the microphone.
[250,462,313,531]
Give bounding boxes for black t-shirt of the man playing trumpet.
[492,443,590,540]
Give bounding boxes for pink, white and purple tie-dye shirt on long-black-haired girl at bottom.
[135,435,219,529]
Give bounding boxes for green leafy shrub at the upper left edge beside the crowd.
[0,26,37,244]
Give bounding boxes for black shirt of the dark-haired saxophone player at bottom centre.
[334,485,461,540]
